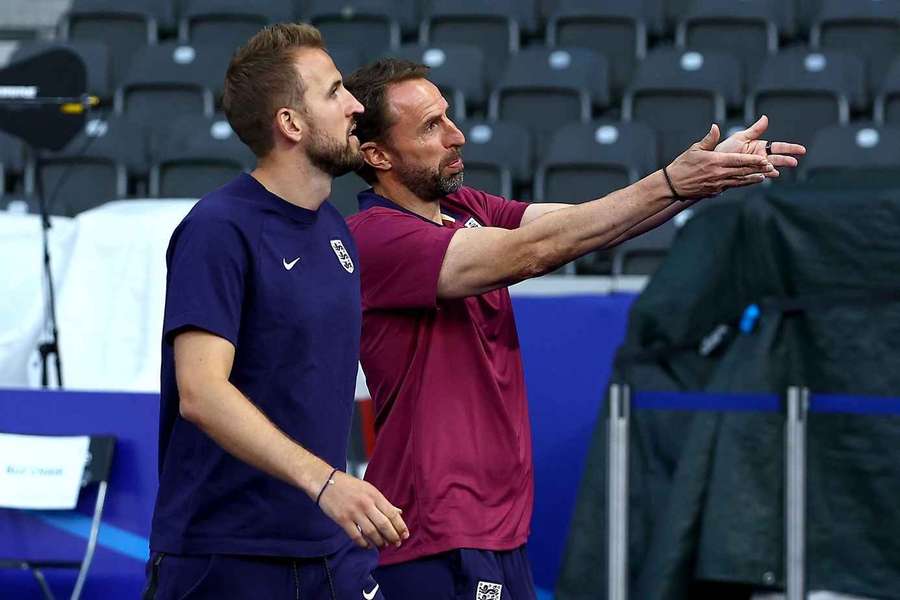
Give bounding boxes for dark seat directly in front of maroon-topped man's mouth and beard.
[458,119,531,198]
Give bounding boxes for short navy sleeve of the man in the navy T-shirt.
[163,218,249,346]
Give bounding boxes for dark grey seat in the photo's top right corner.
[809,0,900,96]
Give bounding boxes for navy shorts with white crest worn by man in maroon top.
[375,546,535,600]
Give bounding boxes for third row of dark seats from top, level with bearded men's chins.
[0,110,900,216]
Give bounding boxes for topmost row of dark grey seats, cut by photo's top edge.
[31,0,900,96]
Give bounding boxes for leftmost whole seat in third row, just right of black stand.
[25,118,146,217]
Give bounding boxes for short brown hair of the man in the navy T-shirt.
[222,23,325,157]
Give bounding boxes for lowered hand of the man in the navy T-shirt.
[319,471,409,548]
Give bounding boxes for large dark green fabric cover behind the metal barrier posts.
[557,186,900,600]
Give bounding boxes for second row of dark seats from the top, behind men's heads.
[8,37,900,168]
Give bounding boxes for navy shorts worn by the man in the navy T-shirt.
[142,540,385,600]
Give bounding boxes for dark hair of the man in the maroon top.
[344,58,429,183]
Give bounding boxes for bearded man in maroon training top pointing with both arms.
[345,59,805,600]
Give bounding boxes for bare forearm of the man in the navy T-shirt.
[182,381,331,498]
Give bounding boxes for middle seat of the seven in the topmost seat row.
[419,0,522,80]
